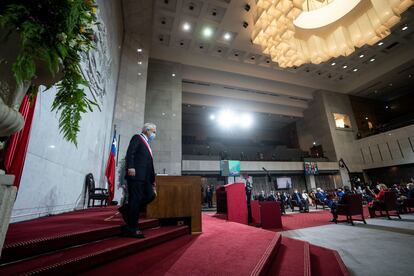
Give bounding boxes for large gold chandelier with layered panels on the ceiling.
[252,0,414,68]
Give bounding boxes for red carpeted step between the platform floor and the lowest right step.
[268,237,310,276]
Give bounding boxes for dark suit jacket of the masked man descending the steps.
[126,134,155,184]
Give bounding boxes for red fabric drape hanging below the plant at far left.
[4,96,36,188]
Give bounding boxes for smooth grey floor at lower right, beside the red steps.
[282,214,414,276]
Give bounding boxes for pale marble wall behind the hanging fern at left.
[12,0,123,221]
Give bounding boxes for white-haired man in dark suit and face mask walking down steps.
[119,123,157,238]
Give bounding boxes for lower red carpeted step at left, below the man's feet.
[0,226,189,275]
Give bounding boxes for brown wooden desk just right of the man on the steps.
[147,176,201,234]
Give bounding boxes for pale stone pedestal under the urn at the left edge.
[0,175,17,256]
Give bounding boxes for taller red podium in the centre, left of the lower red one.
[216,183,248,224]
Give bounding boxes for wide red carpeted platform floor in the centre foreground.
[86,215,280,276]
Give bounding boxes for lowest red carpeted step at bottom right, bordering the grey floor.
[310,245,349,276]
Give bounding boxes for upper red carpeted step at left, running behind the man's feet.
[0,219,159,263]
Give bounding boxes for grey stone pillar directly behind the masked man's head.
[145,59,182,175]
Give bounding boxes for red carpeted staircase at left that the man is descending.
[0,216,189,275]
